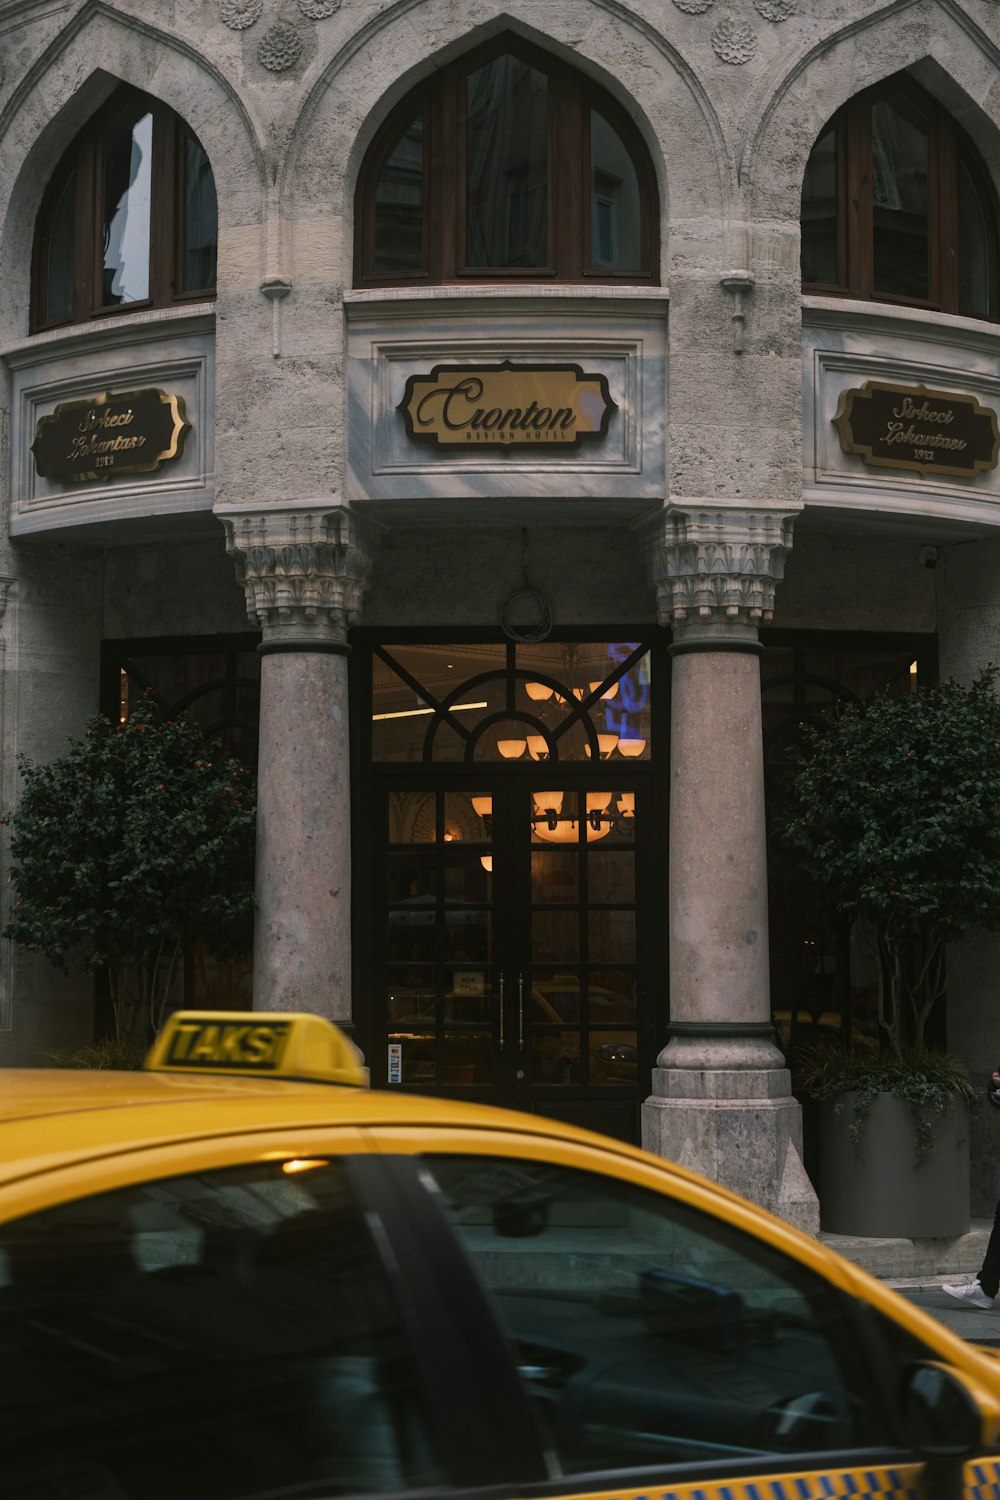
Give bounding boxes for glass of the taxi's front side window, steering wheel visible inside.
[424,1157,894,1475]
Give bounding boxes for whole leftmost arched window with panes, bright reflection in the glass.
[31,89,217,330]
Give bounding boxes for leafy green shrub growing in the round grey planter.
[775,666,1000,1056]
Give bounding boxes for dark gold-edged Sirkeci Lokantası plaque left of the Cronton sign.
[31,389,190,485]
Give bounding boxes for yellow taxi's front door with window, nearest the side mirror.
[364,1131,1000,1500]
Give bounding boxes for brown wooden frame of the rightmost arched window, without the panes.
[802,74,1000,321]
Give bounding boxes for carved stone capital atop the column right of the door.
[649,507,793,626]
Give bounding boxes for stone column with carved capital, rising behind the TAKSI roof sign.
[223,509,372,1029]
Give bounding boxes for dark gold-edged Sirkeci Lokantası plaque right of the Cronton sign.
[834,380,1000,479]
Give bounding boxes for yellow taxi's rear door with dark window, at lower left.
[0,1127,544,1500]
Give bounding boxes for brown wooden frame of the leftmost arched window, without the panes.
[31,86,216,333]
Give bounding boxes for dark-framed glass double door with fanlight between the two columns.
[370,641,663,1139]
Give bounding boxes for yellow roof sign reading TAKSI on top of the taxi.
[144,1011,367,1088]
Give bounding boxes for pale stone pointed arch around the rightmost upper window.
[741,0,1000,233]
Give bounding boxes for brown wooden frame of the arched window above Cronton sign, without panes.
[354,36,660,287]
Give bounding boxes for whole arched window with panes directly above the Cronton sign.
[355,38,658,287]
